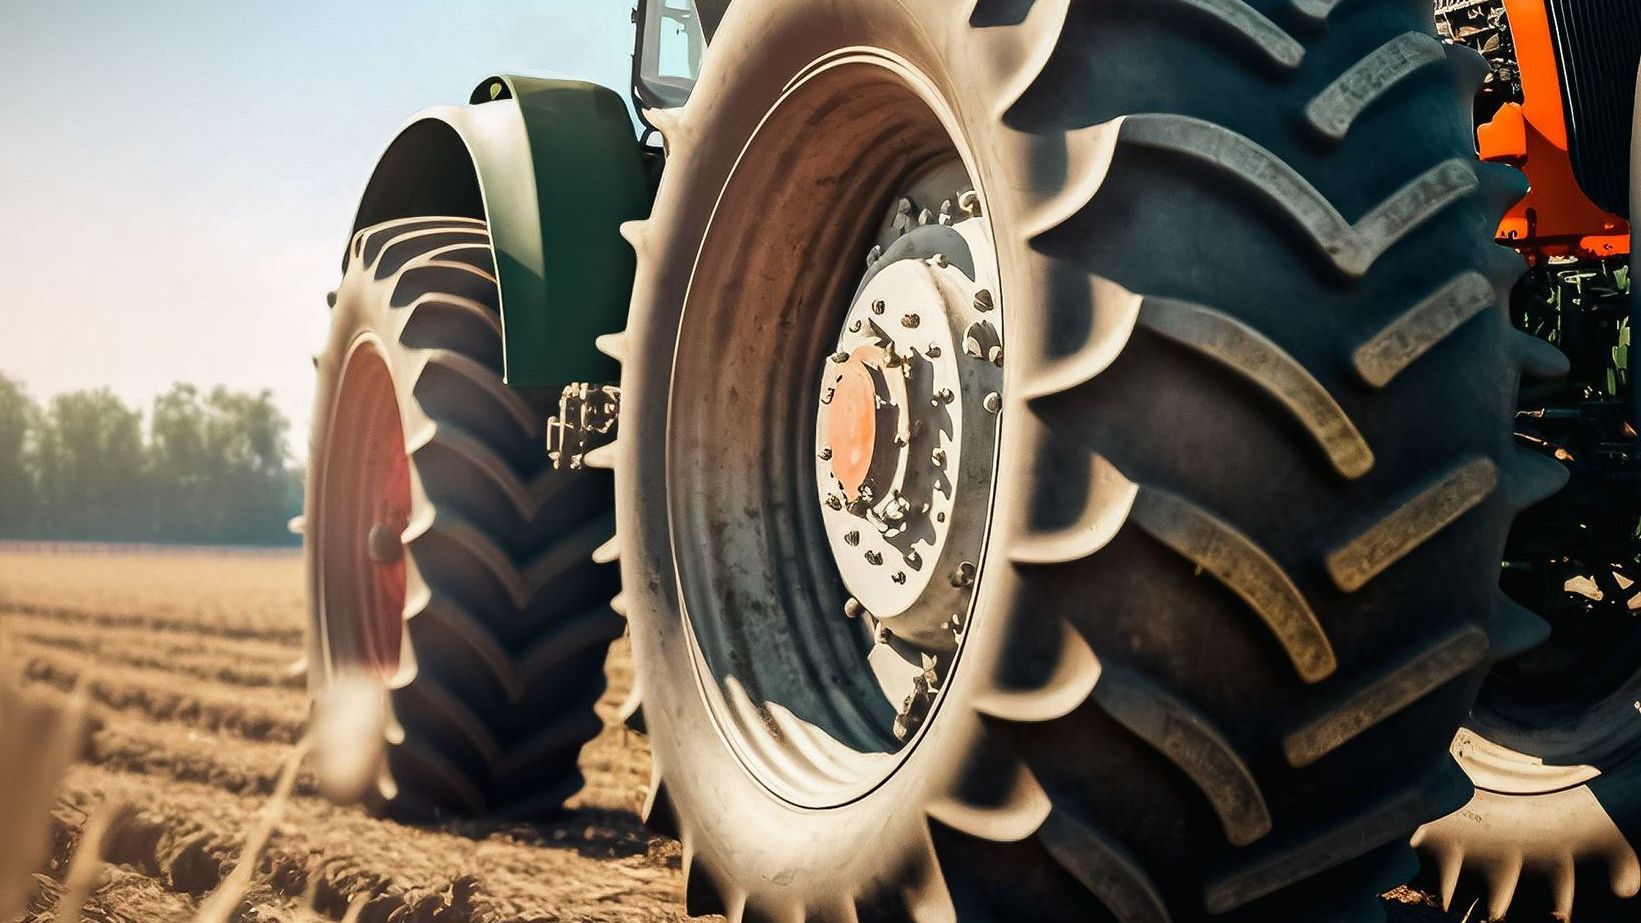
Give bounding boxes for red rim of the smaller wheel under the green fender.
[320,340,410,677]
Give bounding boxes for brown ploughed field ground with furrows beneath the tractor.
[0,549,1460,923]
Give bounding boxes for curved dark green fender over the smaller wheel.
[350,76,655,388]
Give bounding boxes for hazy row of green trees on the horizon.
[0,366,302,545]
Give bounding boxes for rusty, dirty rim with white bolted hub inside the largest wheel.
[653,64,1006,791]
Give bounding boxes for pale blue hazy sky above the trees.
[0,0,632,452]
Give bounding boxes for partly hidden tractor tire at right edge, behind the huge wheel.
[1415,430,1641,921]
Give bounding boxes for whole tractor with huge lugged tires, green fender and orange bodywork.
[304,0,1641,923]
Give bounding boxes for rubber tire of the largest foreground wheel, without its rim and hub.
[610,0,1562,923]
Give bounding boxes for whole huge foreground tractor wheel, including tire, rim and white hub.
[610,0,1559,923]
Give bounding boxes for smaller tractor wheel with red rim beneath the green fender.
[305,217,624,820]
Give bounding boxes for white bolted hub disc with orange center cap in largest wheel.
[816,192,1003,660]
